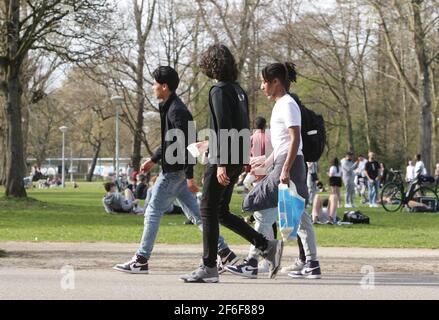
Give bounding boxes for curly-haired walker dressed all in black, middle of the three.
[180,44,283,283]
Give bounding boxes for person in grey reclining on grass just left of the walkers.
[102,182,143,214]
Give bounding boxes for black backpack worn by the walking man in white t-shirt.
[290,93,326,162]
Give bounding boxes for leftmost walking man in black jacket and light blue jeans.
[114,66,238,274]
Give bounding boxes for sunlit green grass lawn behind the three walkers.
[0,182,439,249]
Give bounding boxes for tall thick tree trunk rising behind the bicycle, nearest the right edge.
[411,0,433,172]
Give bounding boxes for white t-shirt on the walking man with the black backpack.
[270,94,303,160]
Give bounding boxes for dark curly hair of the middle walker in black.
[199,44,238,81]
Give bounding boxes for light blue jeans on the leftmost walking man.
[137,170,227,259]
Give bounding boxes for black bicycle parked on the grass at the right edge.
[381,175,439,212]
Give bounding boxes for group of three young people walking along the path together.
[114,44,321,283]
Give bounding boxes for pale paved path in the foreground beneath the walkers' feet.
[0,243,439,300]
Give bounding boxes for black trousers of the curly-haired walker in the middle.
[200,165,268,268]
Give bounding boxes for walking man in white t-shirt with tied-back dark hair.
[226,63,321,279]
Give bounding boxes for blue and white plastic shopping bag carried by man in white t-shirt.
[278,181,305,241]
